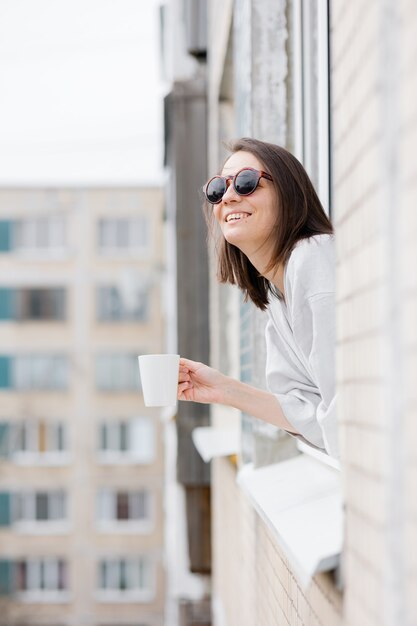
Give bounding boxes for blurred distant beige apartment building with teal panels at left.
[0,186,165,626]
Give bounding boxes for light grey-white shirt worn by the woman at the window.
[266,293,339,457]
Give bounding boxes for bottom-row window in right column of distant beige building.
[99,557,152,594]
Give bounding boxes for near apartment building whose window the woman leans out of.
[164,0,417,626]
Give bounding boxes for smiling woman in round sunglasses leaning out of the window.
[178,139,338,457]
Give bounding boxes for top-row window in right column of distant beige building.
[98,216,150,254]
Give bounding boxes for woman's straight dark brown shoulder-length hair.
[205,138,333,310]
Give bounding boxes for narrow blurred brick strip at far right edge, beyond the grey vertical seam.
[398,0,417,625]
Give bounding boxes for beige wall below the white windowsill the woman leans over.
[212,459,342,626]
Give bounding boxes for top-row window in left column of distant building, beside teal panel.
[11,215,66,252]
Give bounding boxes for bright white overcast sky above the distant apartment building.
[0,0,163,185]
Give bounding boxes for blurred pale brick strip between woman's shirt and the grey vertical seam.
[331,1,389,626]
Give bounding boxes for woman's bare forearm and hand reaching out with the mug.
[178,358,298,434]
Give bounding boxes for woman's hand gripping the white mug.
[178,358,228,404]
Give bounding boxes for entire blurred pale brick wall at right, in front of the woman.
[331,0,417,626]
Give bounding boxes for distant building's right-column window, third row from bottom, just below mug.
[98,416,155,463]
